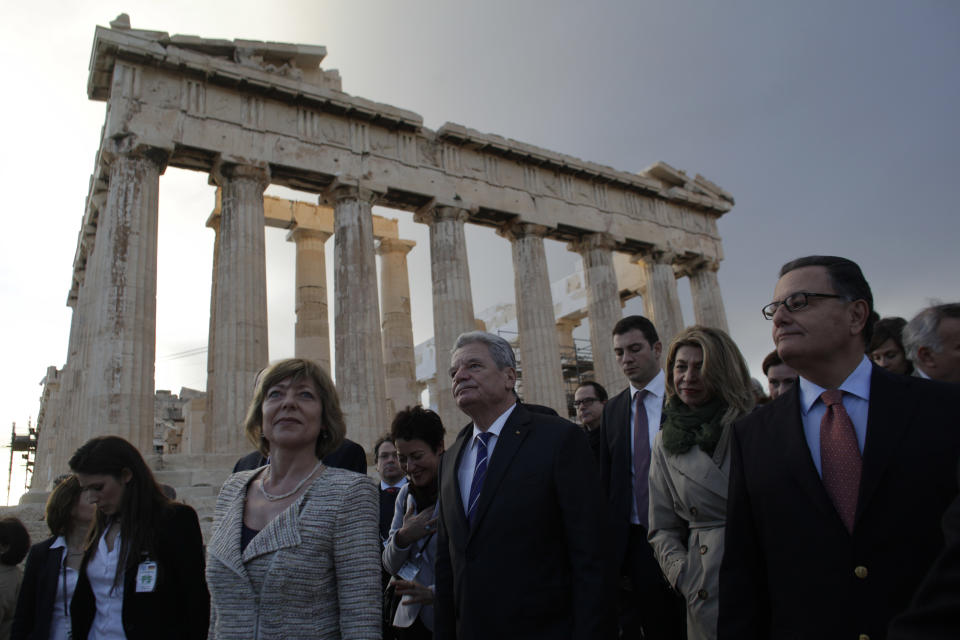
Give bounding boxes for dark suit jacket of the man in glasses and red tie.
[719,366,960,640]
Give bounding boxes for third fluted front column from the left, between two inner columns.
[322,182,390,451]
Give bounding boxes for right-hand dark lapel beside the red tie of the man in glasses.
[854,366,912,526]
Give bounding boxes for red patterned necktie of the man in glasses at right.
[820,389,863,533]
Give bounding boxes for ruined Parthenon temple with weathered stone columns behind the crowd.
[35,17,733,486]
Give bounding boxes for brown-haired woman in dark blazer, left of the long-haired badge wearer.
[10,475,96,640]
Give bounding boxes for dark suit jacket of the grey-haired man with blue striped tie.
[434,405,614,640]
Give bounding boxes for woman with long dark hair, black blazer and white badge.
[70,436,210,640]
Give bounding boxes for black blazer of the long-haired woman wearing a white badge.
[70,504,210,640]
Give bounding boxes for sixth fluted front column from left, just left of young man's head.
[570,233,623,392]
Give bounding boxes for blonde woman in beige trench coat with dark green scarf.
[649,326,753,640]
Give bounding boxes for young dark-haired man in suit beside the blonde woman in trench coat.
[600,316,685,640]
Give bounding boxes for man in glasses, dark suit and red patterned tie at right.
[719,256,960,640]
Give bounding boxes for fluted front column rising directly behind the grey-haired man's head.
[414,207,476,442]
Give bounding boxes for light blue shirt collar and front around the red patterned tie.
[800,356,873,478]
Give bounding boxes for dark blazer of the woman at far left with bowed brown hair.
[10,536,66,640]
